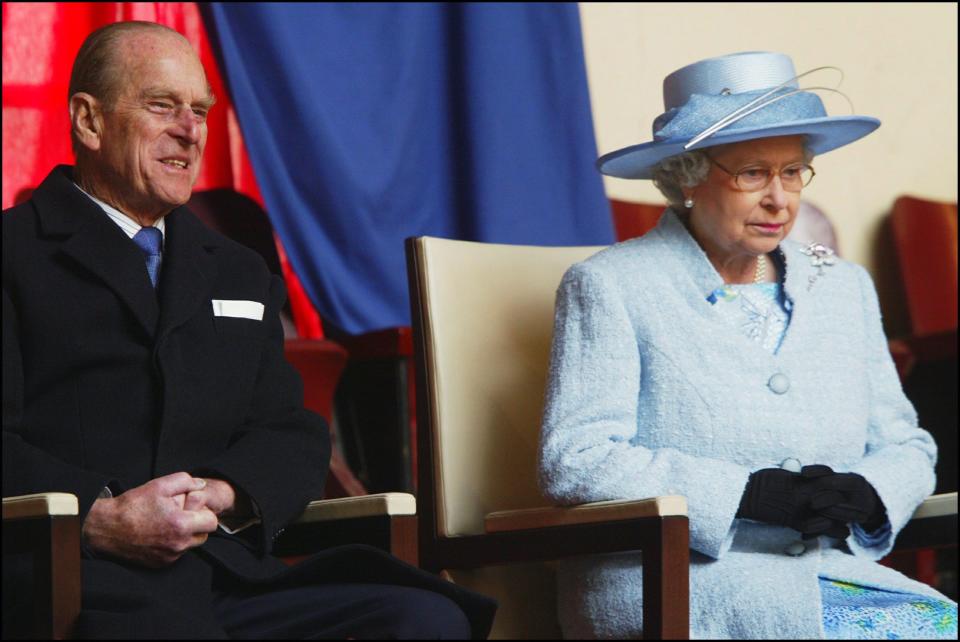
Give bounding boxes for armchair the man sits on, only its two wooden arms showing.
[3,493,417,640]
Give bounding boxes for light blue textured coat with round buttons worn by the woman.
[540,210,943,638]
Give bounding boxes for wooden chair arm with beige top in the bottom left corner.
[3,493,80,640]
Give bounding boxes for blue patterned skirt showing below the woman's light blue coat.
[820,577,957,640]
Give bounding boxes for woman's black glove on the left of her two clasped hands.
[737,465,850,539]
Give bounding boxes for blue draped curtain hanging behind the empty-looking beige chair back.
[205,3,613,333]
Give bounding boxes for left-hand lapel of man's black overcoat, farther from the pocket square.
[33,166,159,337]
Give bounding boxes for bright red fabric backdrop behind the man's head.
[3,2,323,338]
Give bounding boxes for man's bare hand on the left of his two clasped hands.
[83,473,218,568]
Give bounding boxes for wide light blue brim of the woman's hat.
[596,116,880,179]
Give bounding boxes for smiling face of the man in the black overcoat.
[94,32,213,218]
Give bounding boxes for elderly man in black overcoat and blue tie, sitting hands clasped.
[3,22,495,639]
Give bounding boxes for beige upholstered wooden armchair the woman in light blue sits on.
[407,237,957,639]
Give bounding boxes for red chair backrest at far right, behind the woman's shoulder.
[890,196,957,336]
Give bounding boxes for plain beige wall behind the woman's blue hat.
[580,2,957,284]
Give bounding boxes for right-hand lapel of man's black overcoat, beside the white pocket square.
[158,207,219,339]
